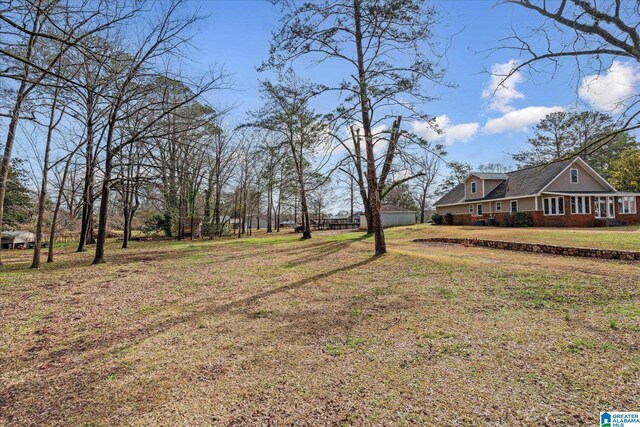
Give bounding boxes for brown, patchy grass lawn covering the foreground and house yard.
[0,226,640,426]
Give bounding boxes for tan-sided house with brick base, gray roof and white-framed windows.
[435,157,640,227]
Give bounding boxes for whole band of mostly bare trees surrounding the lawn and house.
[0,0,640,268]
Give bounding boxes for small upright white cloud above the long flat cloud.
[482,59,524,113]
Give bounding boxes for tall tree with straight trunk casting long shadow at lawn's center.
[262,0,450,255]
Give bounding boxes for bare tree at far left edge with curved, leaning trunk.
[0,0,135,263]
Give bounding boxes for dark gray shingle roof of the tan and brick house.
[435,160,571,205]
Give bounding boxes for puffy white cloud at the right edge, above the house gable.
[578,61,640,113]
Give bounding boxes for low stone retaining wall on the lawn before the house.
[414,237,640,261]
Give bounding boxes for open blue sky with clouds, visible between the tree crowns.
[181,0,640,172]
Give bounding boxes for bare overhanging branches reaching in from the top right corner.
[496,0,640,155]
